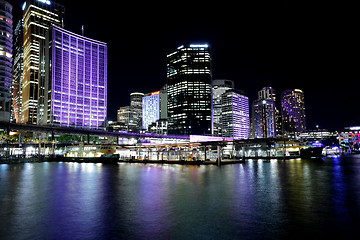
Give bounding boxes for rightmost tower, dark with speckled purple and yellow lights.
[281,89,306,135]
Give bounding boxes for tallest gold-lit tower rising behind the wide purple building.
[21,0,65,124]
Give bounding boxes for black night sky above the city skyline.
[10,0,360,129]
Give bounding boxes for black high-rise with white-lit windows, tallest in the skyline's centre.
[167,44,212,135]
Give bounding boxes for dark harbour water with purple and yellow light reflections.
[0,155,360,240]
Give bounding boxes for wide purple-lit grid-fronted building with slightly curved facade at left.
[38,26,107,128]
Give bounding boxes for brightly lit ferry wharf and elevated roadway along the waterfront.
[0,123,306,165]
